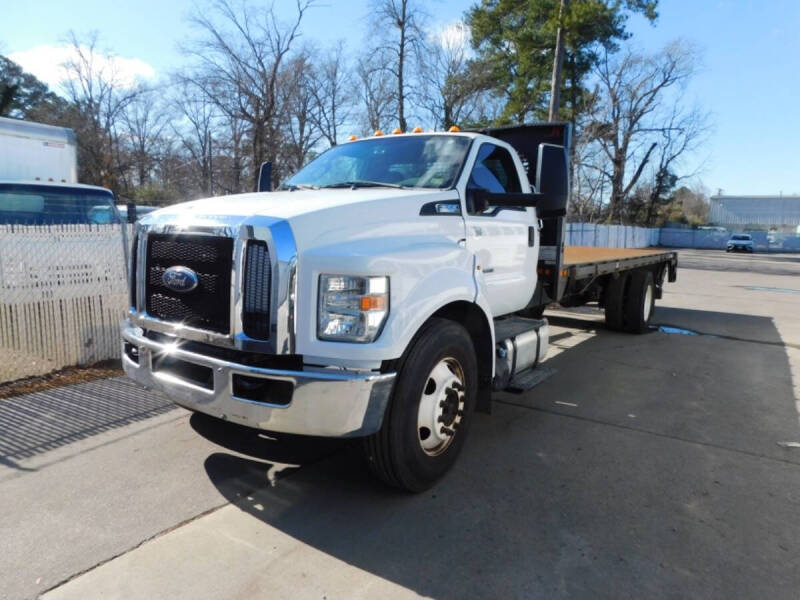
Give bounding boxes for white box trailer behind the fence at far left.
[0,117,78,183]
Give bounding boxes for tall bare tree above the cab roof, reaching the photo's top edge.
[372,0,425,131]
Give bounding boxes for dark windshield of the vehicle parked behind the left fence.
[0,183,119,225]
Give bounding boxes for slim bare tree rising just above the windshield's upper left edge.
[309,42,353,146]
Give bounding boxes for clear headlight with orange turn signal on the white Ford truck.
[317,275,389,344]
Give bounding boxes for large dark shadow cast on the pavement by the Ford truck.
[192,309,800,598]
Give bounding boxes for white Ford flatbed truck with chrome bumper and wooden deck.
[123,123,677,491]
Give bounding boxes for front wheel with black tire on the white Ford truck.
[364,318,478,492]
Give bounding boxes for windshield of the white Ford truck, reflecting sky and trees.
[280,134,471,190]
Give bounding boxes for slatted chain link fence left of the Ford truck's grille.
[0,225,130,383]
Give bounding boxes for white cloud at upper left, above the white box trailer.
[8,45,156,90]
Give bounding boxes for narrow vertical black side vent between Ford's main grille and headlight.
[242,240,272,340]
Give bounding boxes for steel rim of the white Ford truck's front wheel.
[417,357,465,456]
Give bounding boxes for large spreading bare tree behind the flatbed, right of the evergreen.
[587,41,696,222]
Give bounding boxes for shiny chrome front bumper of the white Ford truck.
[122,322,395,437]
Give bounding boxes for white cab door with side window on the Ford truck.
[464,142,539,316]
